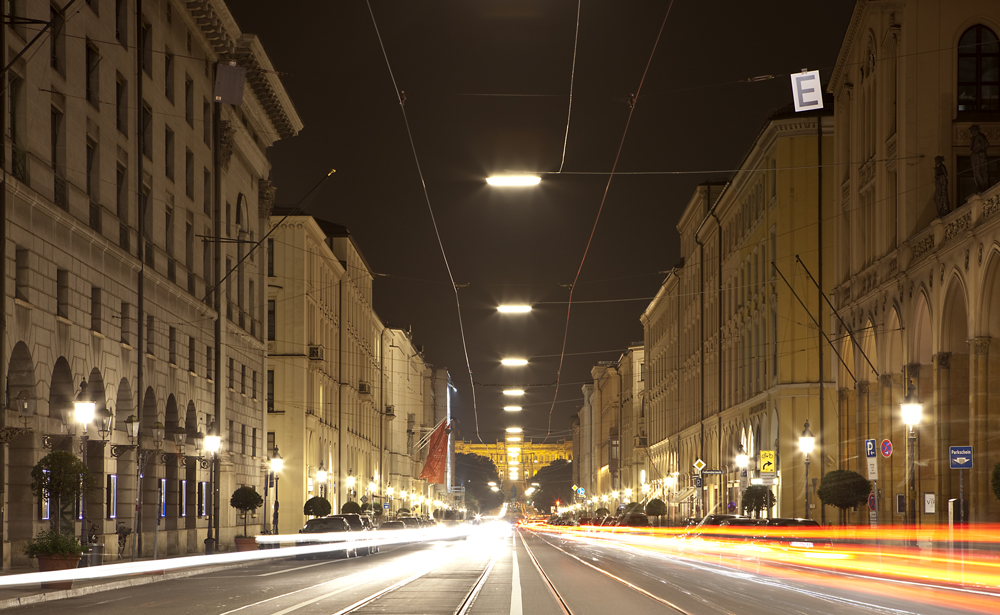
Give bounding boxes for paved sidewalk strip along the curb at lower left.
[0,554,258,610]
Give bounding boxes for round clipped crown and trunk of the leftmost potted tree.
[31,451,94,534]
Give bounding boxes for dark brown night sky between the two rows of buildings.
[229,0,854,442]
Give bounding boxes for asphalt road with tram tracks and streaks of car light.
[7,530,1000,615]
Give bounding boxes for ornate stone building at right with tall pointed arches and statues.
[828,0,1000,523]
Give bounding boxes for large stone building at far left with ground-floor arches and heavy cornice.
[0,0,302,568]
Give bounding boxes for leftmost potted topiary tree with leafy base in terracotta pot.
[24,451,94,589]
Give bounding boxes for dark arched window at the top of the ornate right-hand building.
[958,25,1000,112]
